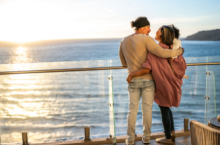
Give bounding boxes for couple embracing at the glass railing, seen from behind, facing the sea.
[119,17,186,145]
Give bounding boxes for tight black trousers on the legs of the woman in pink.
[158,105,174,139]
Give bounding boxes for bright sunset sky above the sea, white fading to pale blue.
[0,0,220,42]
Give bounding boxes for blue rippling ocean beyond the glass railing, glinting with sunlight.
[0,39,220,144]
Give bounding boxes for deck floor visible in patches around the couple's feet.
[102,136,191,145]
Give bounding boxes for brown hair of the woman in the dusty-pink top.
[160,25,174,49]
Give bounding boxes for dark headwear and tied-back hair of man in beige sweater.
[131,17,150,30]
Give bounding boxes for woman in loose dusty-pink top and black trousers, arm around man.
[127,26,187,144]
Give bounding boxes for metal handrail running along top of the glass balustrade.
[0,62,220,75]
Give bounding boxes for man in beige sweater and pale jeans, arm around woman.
[119,17,183,145]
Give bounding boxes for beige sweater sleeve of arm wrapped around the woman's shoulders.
[145,36,183,58]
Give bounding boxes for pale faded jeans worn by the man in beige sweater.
[127,78,155,141]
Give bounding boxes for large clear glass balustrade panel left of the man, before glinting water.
[0,67,110,143]
